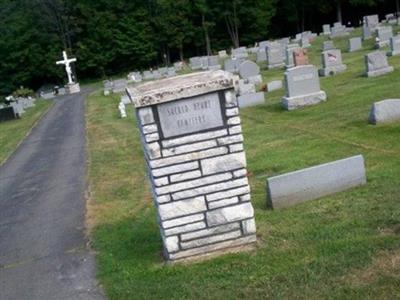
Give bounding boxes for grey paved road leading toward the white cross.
[0,94,103,300]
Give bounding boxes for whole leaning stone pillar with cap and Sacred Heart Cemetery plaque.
[128,71,256,261]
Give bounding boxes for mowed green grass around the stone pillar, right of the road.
[87,26,400,299]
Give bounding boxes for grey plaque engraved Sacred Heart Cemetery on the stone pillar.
[157,93,224,138]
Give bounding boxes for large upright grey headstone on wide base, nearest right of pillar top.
[282,65,326,110]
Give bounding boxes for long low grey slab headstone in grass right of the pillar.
[267,155,367,208]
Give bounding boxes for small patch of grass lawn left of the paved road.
[0,100,52,165]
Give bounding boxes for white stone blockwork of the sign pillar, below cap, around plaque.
[137,88,256,260]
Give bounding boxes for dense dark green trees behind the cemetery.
[0,0,398,95]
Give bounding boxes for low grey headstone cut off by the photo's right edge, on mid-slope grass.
[369,99,400,125]
